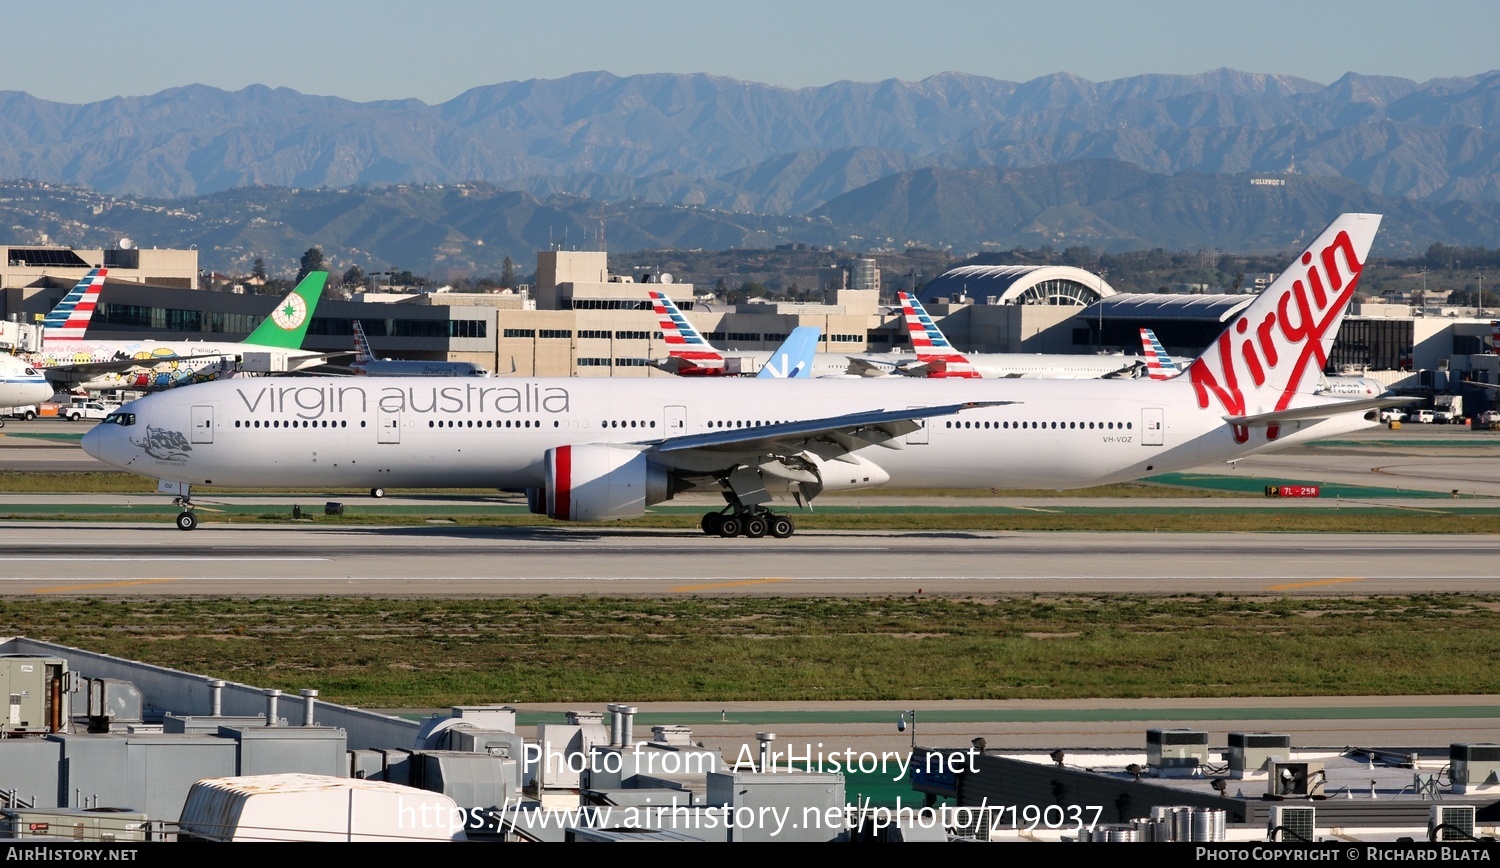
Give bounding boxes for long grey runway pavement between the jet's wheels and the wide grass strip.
[0,522,1500,597]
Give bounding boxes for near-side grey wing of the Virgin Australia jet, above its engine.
[648,400,1017,459]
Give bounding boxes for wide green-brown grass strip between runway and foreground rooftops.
[0,595,1500,708]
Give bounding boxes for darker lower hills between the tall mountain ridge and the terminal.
[0,168,1500,279]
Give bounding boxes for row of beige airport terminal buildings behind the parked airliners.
[0,246,1500,405]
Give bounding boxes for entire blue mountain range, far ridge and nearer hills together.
[0,69,1500,267]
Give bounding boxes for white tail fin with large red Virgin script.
[1188,214,1380,442]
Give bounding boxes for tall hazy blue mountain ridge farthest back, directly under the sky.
[0,69,1500,208]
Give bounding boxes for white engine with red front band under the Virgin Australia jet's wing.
[543,444,671,522]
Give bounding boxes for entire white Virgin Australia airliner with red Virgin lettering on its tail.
[83,214,1389,537]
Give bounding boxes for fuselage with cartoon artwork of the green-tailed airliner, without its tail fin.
[27,340,323,391]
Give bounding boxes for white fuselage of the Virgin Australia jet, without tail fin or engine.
[83,378,1377,489]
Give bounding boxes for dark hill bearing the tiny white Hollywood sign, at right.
[813,160,1500,255]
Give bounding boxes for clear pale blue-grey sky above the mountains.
[11,0,1500,103]
